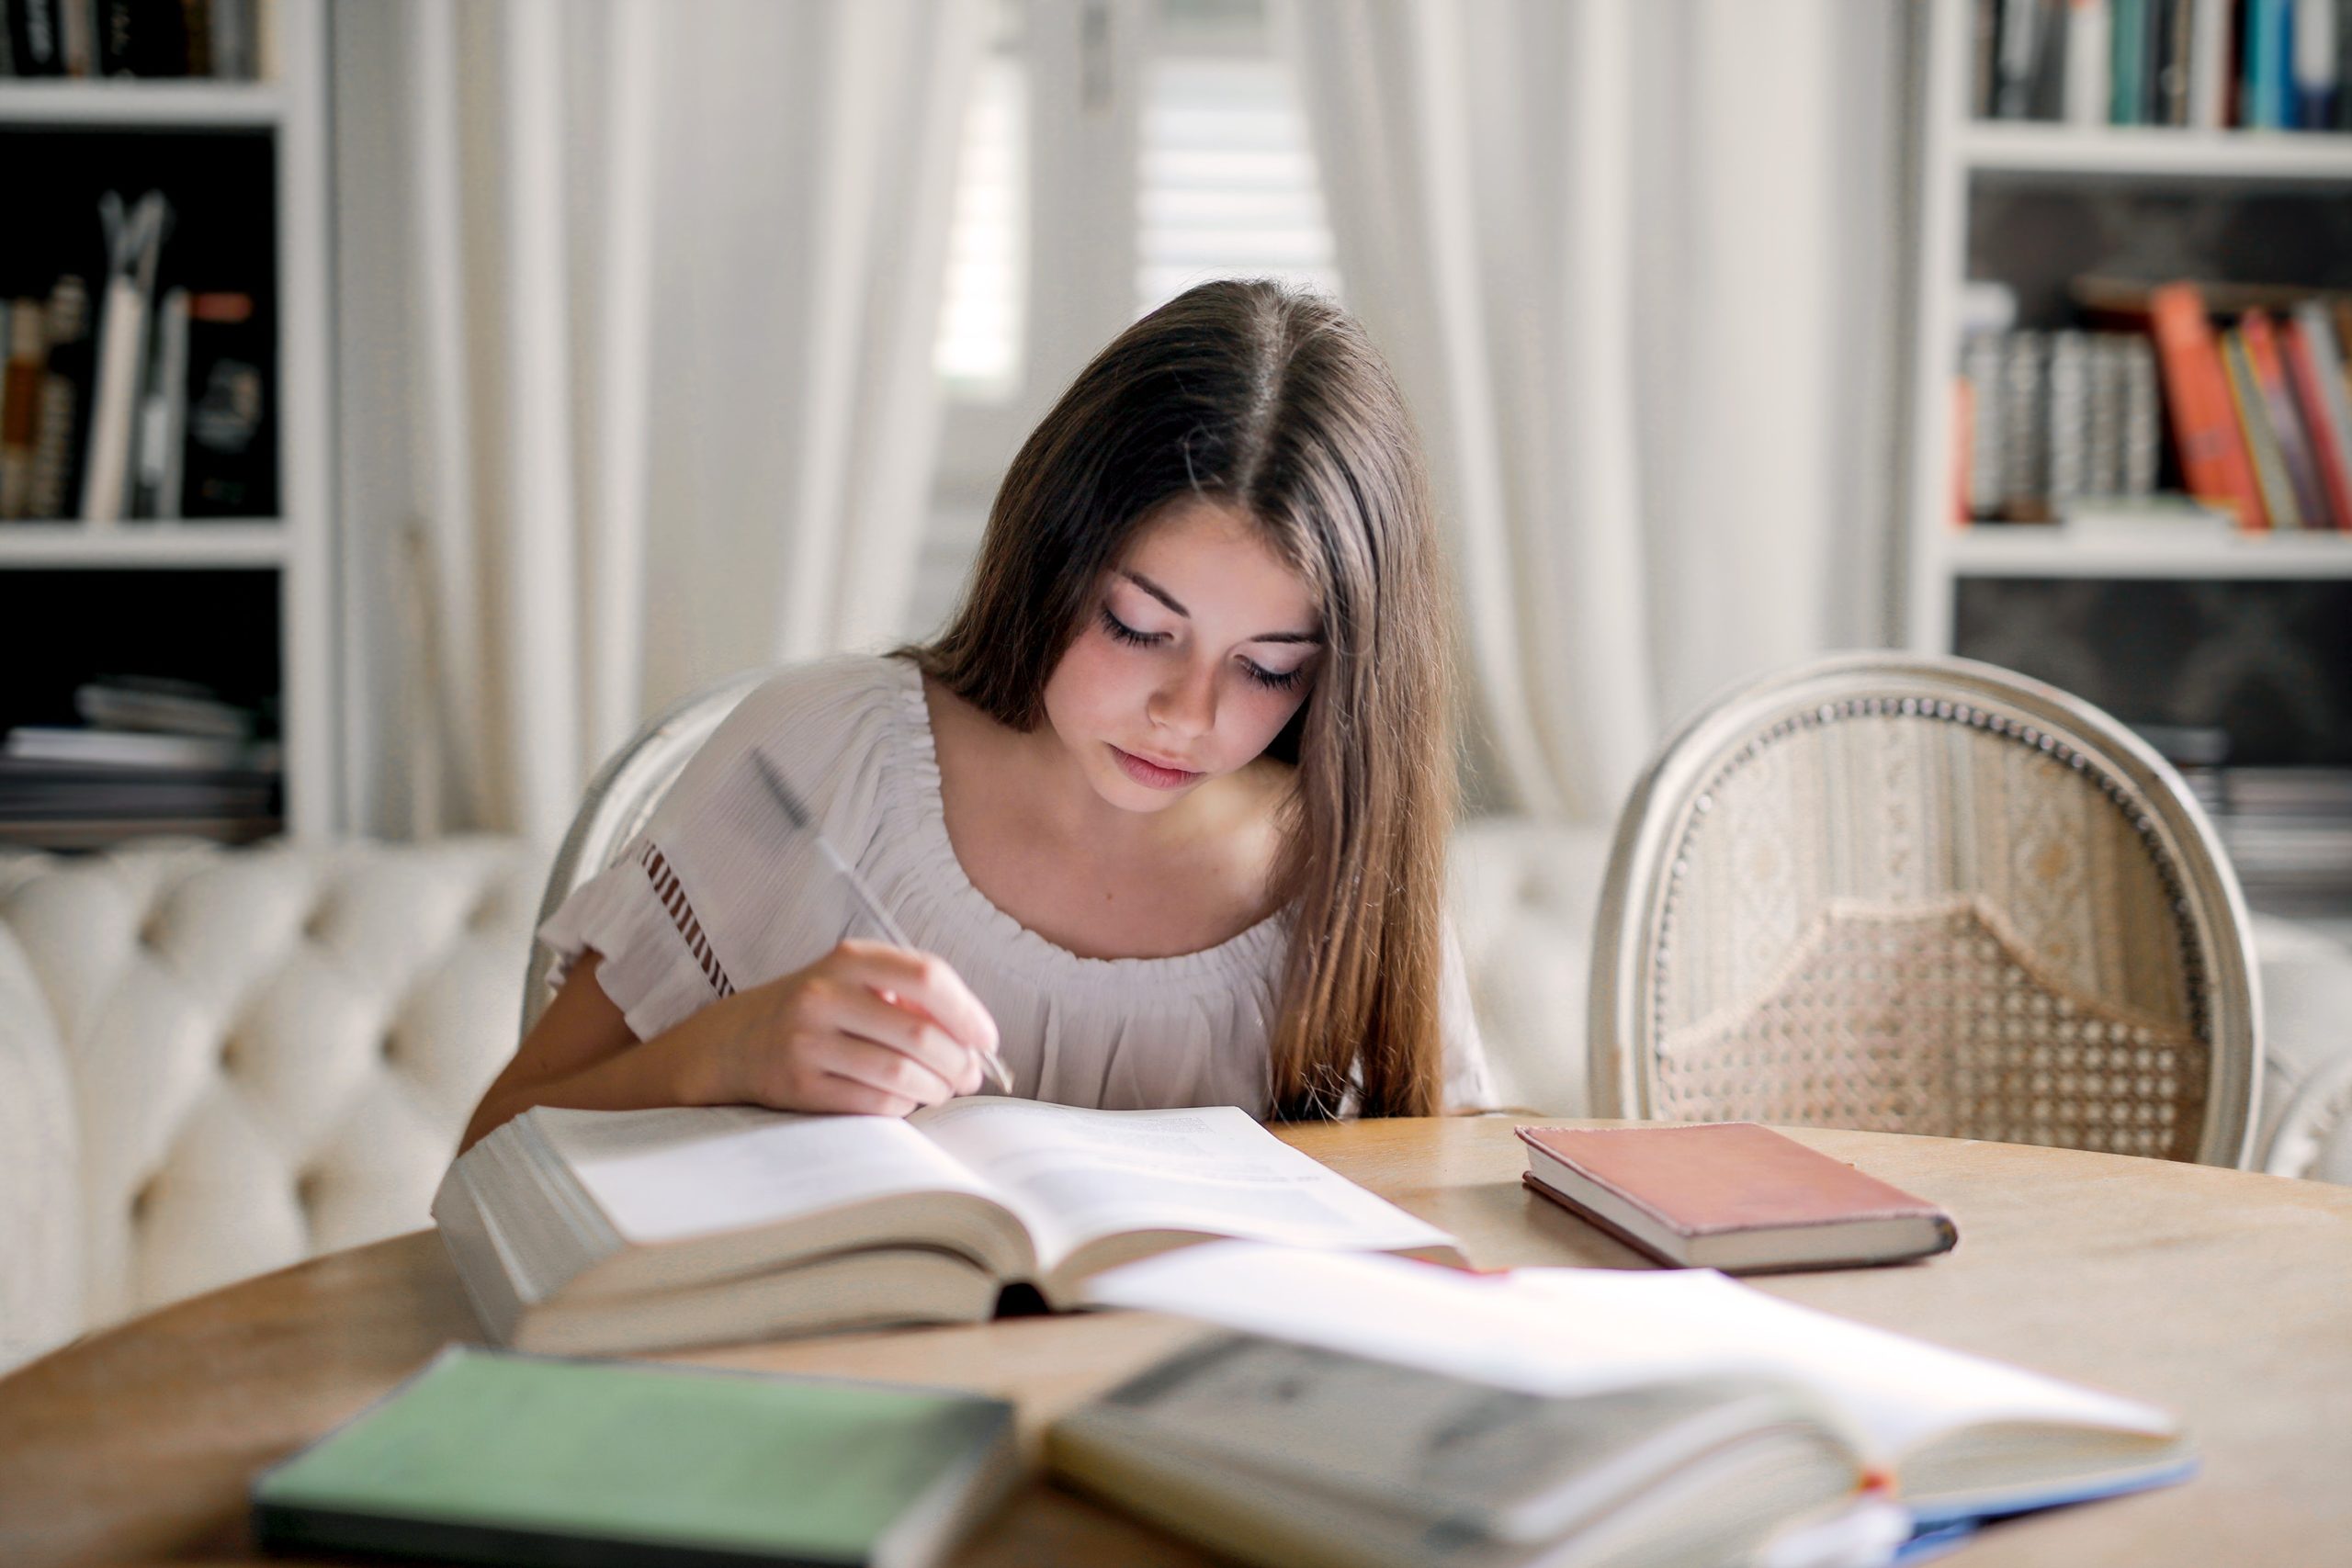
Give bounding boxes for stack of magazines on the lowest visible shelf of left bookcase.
[0,677,282,849]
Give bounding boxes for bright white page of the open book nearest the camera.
[1087,1244,2178,1462]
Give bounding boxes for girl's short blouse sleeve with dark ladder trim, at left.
[538,659,891,1039]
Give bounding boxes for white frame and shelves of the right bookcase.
[1903,0,2352,653]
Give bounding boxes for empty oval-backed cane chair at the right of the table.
[1588,653,2260,1166]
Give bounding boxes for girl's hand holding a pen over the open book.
[694,941,997,1117]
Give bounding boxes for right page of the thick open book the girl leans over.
[910,1096,1453,1269]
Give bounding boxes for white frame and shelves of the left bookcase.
[0,0,344,837]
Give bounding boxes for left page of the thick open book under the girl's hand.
[529,1105,992,1241]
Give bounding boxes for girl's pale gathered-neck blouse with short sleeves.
[538,656,1491,1119]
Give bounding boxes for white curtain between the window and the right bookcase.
[1286,0,1903,823]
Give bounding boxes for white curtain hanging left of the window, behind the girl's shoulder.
[336,0,986,841]
